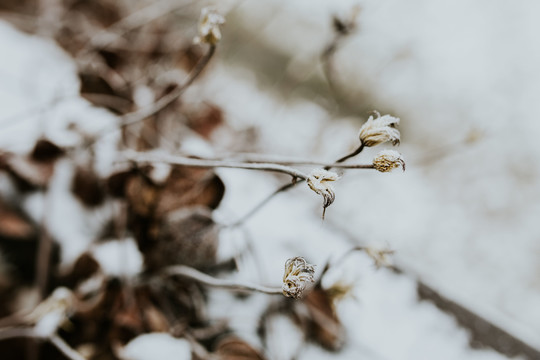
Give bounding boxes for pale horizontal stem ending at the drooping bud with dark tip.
[124,151,307,180]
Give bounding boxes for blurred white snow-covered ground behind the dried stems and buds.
[0,0,540,360]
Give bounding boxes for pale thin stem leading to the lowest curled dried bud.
[164,265,283,295]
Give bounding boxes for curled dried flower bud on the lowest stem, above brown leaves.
[282,256,315,299]
